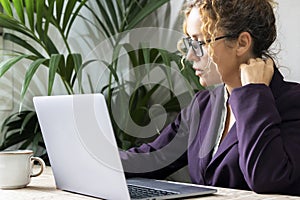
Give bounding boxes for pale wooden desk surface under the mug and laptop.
[0,167,300,200]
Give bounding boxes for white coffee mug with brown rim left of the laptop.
[0,150,45,189]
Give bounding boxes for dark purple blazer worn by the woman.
[120,69,300,195]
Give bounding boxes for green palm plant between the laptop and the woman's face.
[83,0,202,149]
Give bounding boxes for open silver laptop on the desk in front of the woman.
[33,94,216,200]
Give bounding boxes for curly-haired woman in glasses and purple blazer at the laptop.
[121,0,300,195]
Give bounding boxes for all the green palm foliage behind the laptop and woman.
[0,0,202,163]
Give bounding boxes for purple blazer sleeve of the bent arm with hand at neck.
[229,84,300,194]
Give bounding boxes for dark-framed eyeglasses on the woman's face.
[183,35,235,57]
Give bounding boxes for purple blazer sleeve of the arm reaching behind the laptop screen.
[120,90,210,179]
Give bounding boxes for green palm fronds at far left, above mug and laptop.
[0,0,87,159]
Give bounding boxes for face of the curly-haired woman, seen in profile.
[186,7,239,86]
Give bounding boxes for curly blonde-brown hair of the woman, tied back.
[183,0,277,57]
